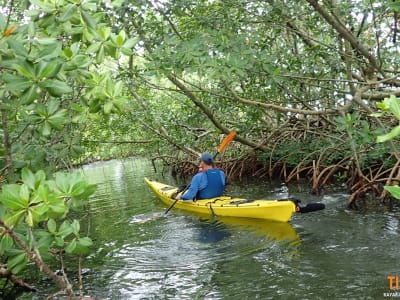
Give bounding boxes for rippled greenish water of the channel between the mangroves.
[21,159,400,299]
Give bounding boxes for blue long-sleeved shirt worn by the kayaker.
[181,169,225,200]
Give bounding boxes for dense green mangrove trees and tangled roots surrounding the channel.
[0,0,400,294]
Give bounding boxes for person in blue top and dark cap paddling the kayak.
[176,152,225,200]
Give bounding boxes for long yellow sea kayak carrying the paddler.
[144,178,296,222]
